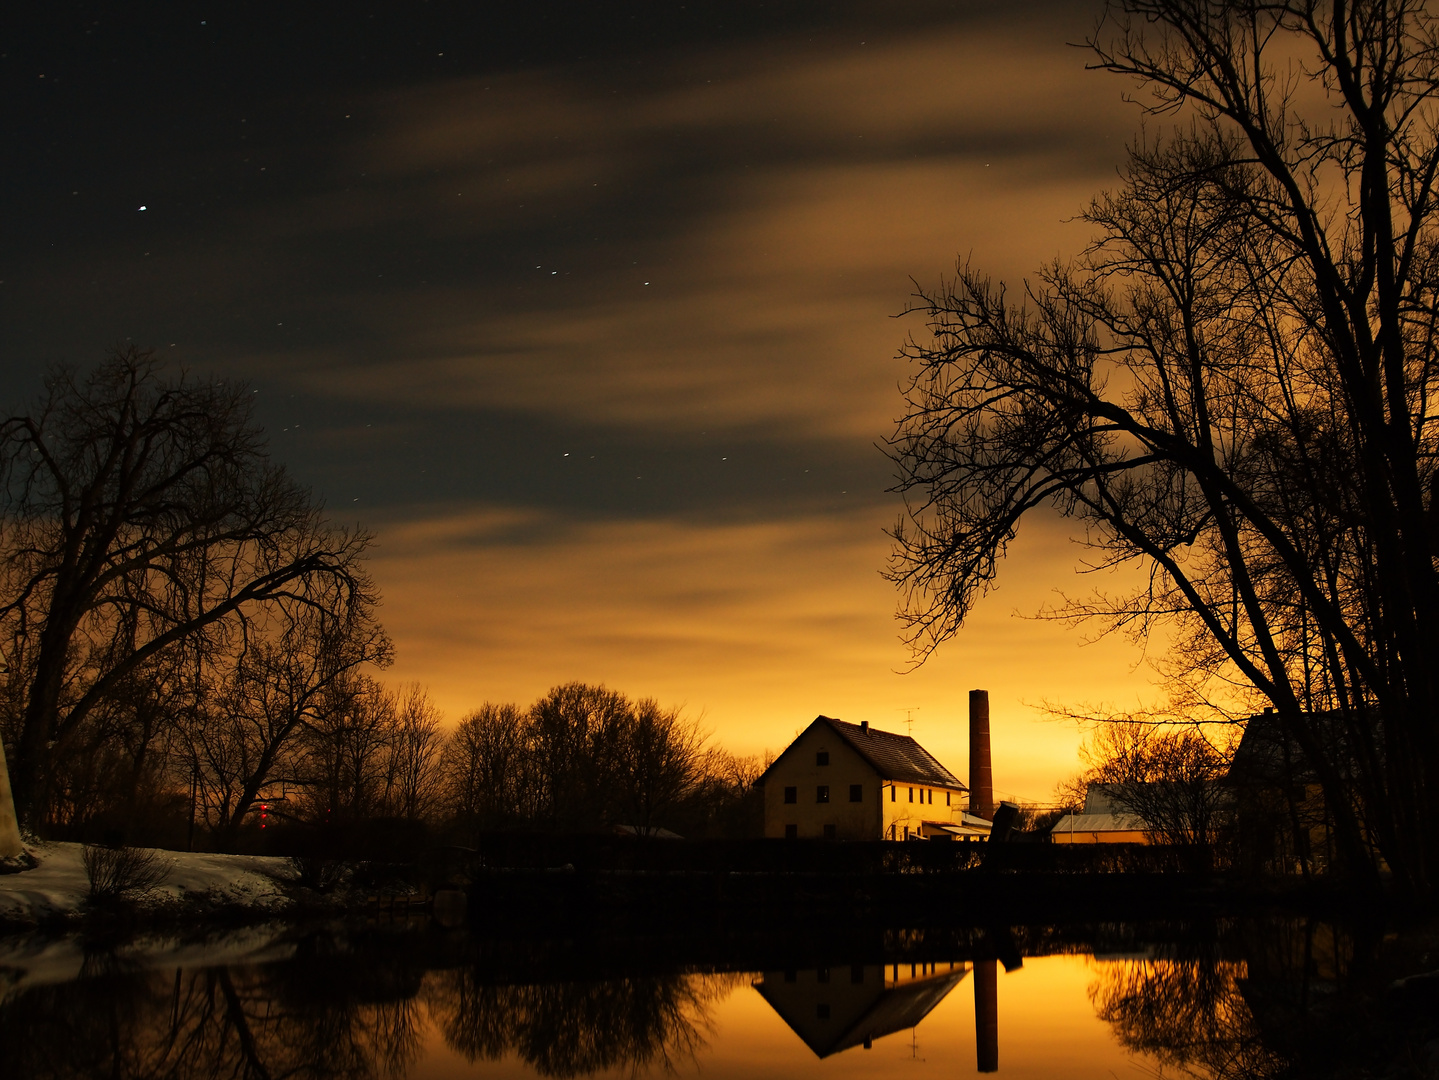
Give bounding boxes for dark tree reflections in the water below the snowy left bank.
[0,965,423,1080]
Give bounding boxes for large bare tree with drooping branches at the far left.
[0,348,374,825]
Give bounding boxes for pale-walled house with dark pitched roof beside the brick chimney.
[755,716,990,840]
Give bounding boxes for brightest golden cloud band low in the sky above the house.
[376,508,1143,797]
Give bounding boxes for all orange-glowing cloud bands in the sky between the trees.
[345,12,1153,800]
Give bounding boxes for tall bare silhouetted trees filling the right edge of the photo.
[892,0,1439,892]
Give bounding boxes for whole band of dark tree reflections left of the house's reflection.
[0,949,744,1080]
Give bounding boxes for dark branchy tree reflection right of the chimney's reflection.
[1089,958,1284,1080]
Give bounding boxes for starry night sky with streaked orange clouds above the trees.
[0,0,1157,801]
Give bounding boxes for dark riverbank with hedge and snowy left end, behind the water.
[0,838,1387,935]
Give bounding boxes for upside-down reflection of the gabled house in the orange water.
[754,964,970,1057]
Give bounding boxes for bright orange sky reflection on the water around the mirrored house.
[407,956,1154,1080]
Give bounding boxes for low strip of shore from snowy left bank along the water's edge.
[0,843,1404,941]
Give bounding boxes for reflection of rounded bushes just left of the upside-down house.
[425,969,744,1077]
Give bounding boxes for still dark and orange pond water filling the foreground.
[0,920,1422,1080]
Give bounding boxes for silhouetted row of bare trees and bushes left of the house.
[0,348,761,850]
